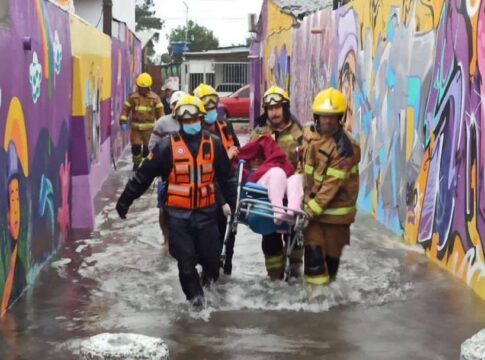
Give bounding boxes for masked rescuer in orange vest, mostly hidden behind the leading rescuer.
[194,84,240,275]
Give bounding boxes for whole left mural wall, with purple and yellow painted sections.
[0,0,140,316]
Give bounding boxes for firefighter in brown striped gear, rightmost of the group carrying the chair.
[303,88,360,285]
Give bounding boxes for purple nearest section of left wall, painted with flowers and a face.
[0,0,72,316]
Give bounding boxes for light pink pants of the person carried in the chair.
[258,167,303,224]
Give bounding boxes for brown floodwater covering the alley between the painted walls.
[0,148,485,360]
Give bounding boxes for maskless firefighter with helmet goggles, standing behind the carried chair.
[250,86,303,280]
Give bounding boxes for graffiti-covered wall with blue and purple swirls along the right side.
[255,0,485,298]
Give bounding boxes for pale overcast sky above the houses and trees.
[154,0,263,54]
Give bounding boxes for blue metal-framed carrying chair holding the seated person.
[222,160,308,280]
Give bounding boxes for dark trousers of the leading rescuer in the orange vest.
[167,207,222,300]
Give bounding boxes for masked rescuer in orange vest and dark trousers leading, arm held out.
[116,95,236,309]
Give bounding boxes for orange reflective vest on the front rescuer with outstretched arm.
[167,131,216,210]
